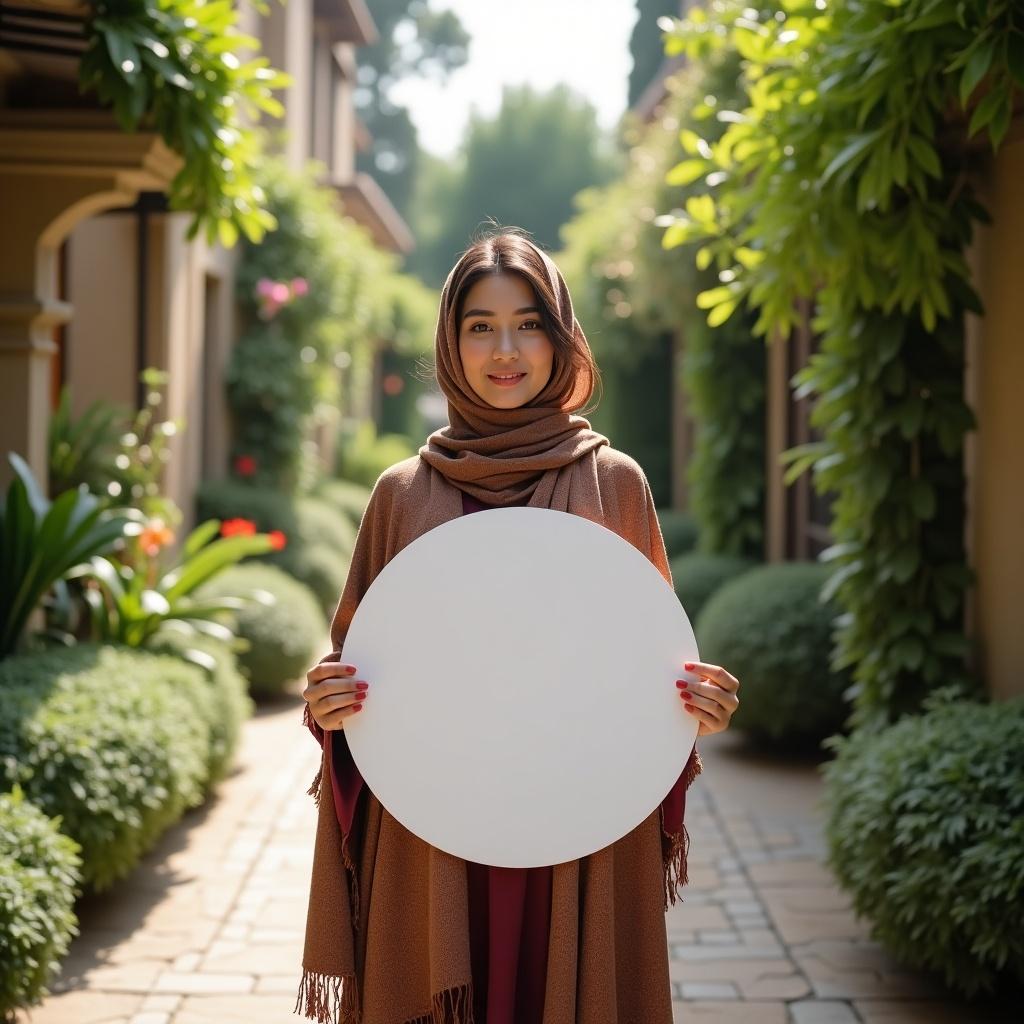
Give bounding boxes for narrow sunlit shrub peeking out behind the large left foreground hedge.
[148,627,255,788]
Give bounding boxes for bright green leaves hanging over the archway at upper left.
[79,0,292,248]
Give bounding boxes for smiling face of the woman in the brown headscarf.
[459,273,555,409]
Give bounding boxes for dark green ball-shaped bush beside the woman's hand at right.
[696,562,850,744]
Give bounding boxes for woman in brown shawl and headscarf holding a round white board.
[296,231,738,1024]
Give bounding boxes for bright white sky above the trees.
[390,0,637,157]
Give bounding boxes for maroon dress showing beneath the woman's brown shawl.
[307,493,686,1024]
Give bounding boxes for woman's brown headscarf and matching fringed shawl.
[296,233,700,1024]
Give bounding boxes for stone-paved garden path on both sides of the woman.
[16,696,1024,1024]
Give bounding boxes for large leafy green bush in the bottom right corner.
[824,695,1024,994]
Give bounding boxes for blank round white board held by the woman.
[342,508,697,867]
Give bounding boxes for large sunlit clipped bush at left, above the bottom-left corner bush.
[0,644,216,891]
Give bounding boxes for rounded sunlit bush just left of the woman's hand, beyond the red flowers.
[195,562,328,694]
